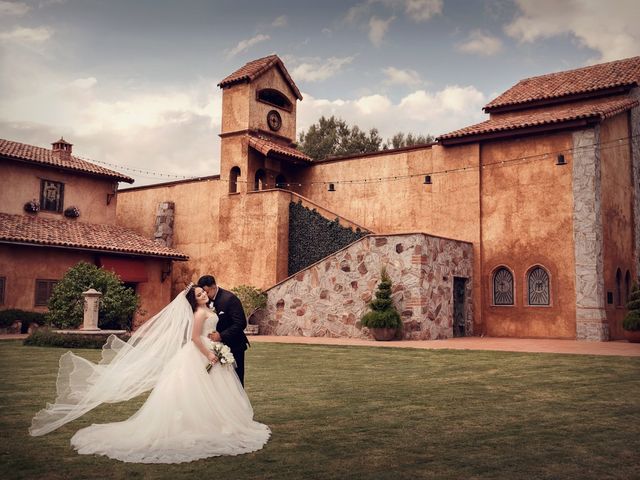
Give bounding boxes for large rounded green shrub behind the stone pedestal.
[46,262,140,330]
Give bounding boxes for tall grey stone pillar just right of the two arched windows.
[572,126,609,341]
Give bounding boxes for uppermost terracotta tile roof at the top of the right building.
[484,57,640,112]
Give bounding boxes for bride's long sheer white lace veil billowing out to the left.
[29,289,193,436]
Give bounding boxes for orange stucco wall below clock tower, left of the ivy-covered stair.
[118,179,290,295]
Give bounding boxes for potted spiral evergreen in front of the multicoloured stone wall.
[360,268,401,340]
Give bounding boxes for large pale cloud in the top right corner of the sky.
[505,0,640,61]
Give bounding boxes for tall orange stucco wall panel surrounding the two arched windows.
[480,132,576,338]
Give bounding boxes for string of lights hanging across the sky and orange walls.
[74,135,640,187]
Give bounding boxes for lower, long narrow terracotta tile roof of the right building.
[437,97,639,141]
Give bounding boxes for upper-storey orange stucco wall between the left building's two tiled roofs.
[0,160,117,223]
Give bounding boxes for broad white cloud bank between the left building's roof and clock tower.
[0,45,222,185]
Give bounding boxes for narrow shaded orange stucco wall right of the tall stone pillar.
[600,113,637,339]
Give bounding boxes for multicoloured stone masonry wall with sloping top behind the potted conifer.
[258,233,473,340]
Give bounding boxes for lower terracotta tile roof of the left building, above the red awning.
[0,213,189,260]
